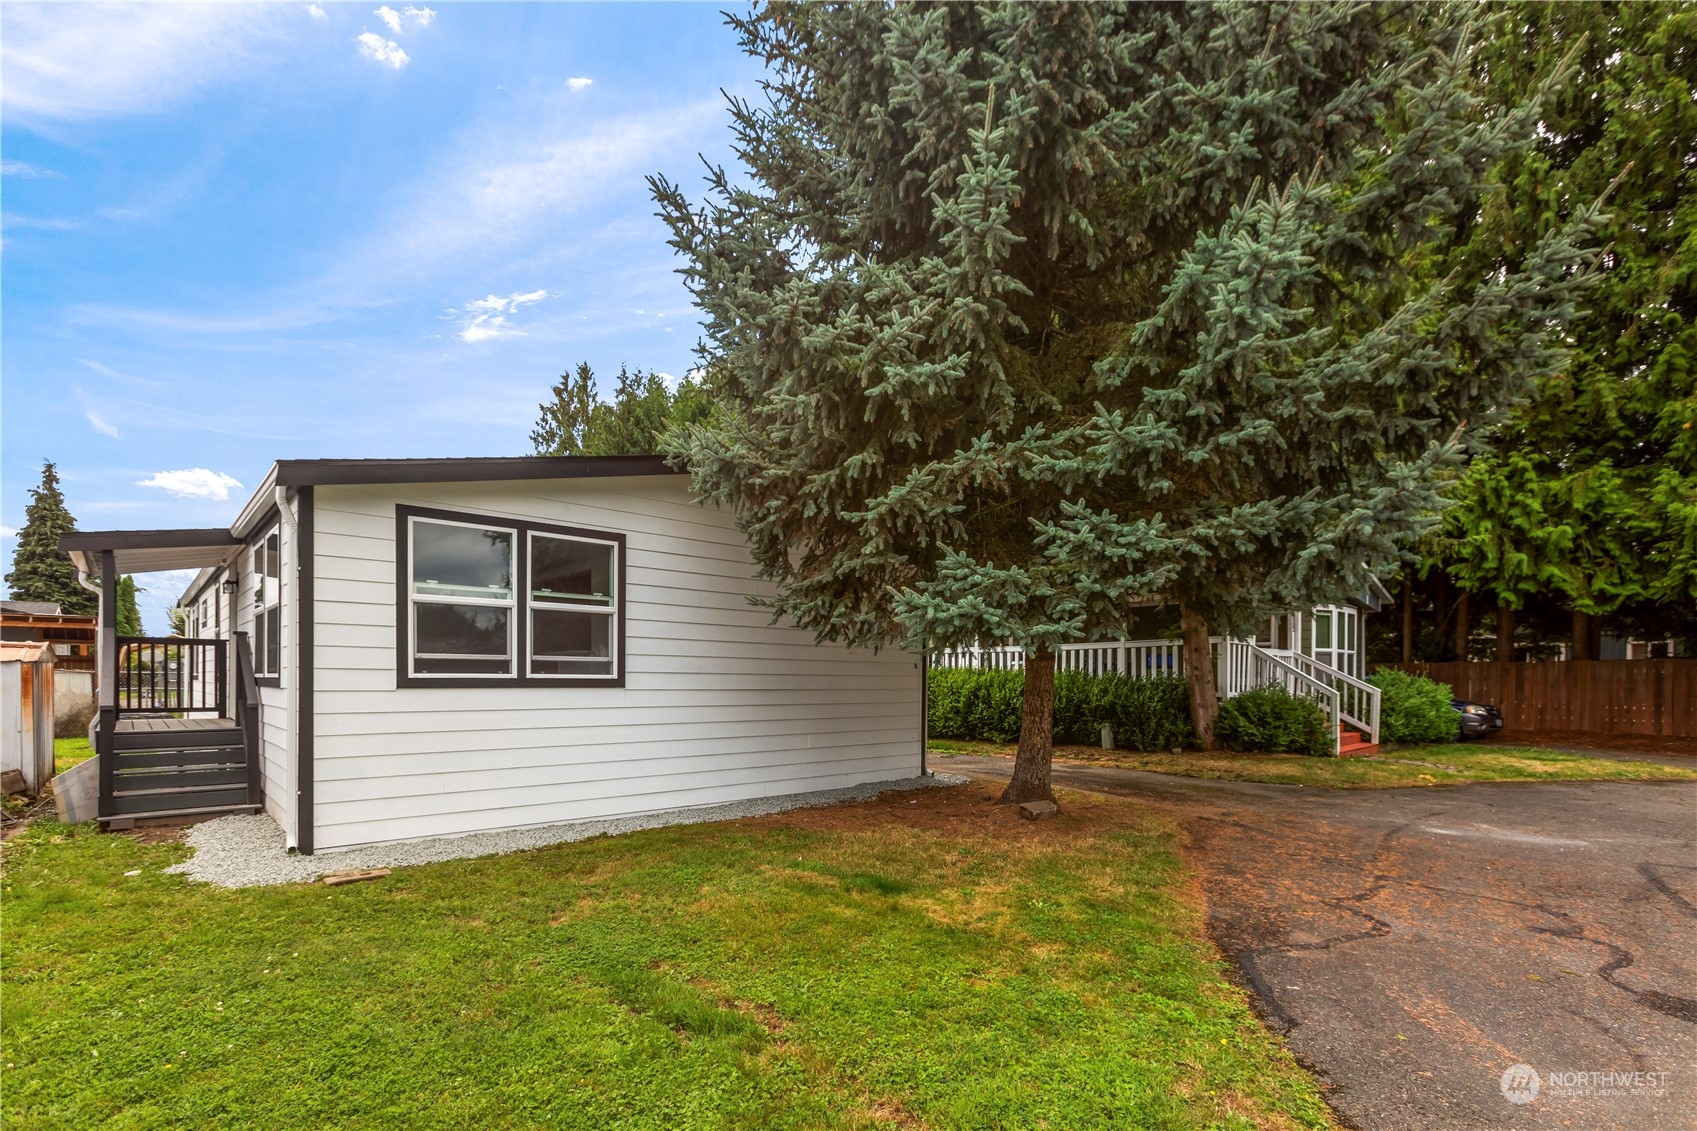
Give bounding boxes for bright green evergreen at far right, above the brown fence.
[1436,2,1697,654]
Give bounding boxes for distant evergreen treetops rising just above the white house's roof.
[531,362,711,455]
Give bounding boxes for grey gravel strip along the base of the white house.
[165,773,969,888]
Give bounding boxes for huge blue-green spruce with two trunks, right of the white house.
[652,3,1582,802]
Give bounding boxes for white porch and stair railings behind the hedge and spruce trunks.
[932,637,1380,746]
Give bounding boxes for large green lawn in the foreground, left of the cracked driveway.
[0,786,1332,1129]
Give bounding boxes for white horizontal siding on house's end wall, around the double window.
[314,475,923,849]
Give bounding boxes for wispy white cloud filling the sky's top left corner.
[0,3,288,121]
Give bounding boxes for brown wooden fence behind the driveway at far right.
[1375,659,1697,739]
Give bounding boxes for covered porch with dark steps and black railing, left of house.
[59,530,263,829]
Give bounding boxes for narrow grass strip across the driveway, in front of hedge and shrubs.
[930,739,1697,790]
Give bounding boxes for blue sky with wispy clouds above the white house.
[0,2,760,630]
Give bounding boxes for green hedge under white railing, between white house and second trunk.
[925,667,1195,751]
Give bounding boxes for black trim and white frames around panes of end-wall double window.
[395,504,628,688]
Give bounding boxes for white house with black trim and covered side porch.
[61,457,925,852]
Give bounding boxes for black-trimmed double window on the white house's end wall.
[395,508,624,686]
